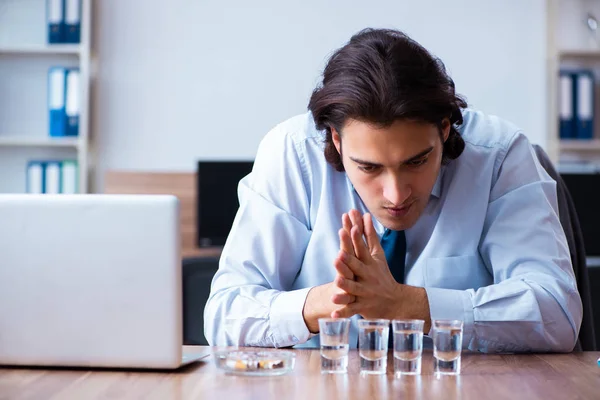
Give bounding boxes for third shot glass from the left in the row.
[392,319,425,375]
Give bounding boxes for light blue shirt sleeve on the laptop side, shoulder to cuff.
[204,127,311,347]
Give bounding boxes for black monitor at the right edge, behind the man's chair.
[560,171,600,257]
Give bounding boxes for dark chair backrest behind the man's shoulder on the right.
[533,145,596,351]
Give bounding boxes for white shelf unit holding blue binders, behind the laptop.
[0,0,93,193]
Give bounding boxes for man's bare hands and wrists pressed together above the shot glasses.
[303,210,431,333]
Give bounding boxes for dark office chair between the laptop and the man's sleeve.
[182,257,219,345]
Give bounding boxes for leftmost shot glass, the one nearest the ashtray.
[319,318,350,374]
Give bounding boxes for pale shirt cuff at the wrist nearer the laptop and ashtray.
[269,288,314,347]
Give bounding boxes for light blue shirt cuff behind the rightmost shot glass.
[425,288,473,348]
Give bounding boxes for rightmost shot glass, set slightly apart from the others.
[433,320,463,375]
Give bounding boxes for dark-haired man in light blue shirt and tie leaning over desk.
[204,30,582,352]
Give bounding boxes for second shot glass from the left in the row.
[358,319,390,374]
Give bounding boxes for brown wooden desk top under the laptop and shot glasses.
[0,347,600,400]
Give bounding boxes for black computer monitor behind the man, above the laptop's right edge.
[196,161,254,247]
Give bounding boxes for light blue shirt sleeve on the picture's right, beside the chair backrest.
[426,133,582,352]
